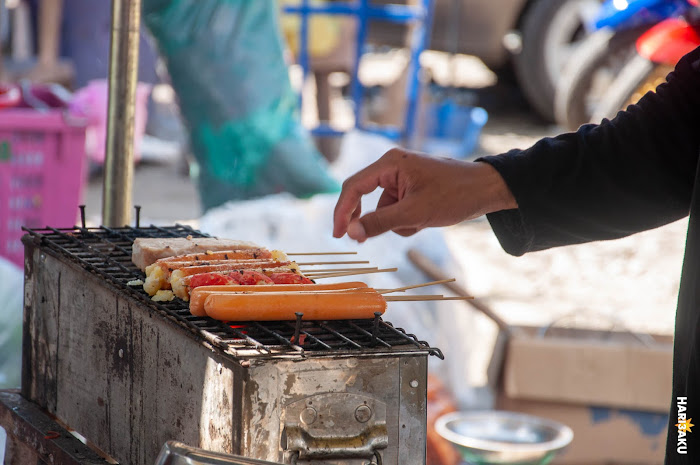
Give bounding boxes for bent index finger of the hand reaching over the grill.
[333,155,396,237]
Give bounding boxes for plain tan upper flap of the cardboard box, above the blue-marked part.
[502,328,673,413]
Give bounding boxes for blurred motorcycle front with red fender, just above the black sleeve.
[591,0,700,123]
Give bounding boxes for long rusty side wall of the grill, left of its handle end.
[22,249,242,465]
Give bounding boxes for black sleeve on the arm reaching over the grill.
[480,48,700,255]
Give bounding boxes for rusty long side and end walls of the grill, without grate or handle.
[22,247,428,465]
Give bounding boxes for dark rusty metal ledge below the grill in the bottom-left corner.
[0,390,110,465]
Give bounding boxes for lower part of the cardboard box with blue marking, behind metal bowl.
[496,395,668,465]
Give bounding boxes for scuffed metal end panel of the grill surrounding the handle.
[241,355,428,465]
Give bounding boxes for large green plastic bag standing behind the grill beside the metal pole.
[143,0,339,210]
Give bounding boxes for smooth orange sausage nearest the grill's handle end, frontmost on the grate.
[204,291,386,321]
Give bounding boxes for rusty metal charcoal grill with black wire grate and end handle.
[10,223,442,465]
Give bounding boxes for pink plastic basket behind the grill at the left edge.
[0,108,85,266]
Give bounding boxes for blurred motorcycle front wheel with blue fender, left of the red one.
[554,0,692,130]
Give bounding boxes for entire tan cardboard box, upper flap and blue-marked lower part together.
[496,327,673,465]
